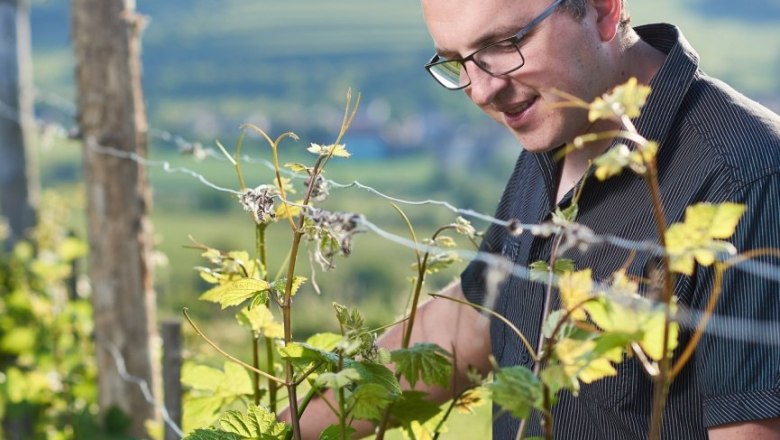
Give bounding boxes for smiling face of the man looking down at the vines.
[422,0,609,152]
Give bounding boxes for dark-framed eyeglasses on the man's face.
[425,0,565,90]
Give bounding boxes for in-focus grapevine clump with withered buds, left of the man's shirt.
[182,93,480,439]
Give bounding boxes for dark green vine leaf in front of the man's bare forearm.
[390,343,452,388]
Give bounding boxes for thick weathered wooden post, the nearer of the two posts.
[71,0,159,437]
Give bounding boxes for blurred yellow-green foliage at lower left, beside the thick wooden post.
[0,192,119,440]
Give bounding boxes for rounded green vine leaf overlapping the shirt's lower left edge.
[487,366,543,419]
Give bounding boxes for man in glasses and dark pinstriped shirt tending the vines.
[304,0,780,440]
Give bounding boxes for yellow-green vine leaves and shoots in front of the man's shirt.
[488,78,745,439]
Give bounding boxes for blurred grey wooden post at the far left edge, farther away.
[0,0,38,246]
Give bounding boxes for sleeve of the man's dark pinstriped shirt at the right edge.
[694,175,780,428]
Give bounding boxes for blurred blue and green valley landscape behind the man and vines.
[0,0,780,436]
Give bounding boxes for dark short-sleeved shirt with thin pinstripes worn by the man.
[461,24,780,439]
